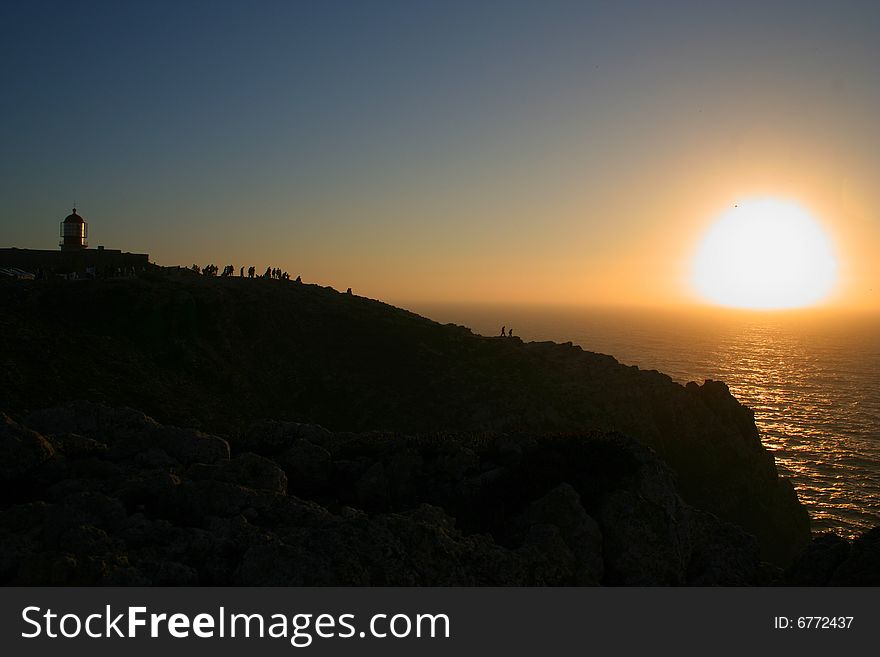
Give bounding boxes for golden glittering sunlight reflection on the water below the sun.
[688,323,880,535]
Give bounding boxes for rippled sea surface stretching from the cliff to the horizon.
[404,304,880,536]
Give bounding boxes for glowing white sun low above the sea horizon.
[691,199,837,310]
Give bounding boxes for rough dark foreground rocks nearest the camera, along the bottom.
[0,403,772,585]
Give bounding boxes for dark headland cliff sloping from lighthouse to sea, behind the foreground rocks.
[0,274,809,564]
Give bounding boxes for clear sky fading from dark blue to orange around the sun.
[0,0,880,309]
